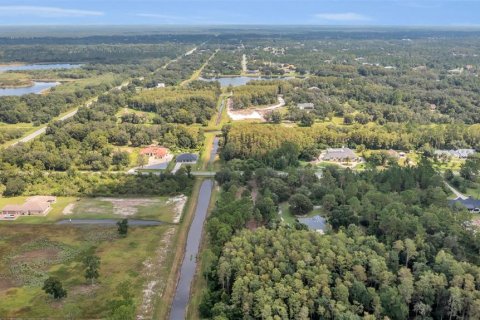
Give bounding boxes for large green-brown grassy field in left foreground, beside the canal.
[0,221,177,319]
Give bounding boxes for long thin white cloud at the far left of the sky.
[0,6,104,18]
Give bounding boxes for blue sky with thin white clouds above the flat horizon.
[0,0,480,26]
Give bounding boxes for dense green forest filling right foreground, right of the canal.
[200,143,480,319]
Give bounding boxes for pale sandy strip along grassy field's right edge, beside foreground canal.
[137,228,175,320]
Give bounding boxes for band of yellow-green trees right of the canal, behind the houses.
[222,123,480,160]
